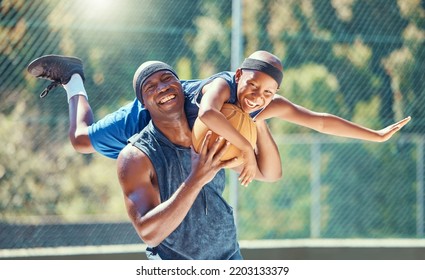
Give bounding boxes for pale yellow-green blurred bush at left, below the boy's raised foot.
[0,96,126,222]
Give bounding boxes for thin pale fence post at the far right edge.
[416,136,424,237]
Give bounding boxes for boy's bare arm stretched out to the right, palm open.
[257,95,411,142]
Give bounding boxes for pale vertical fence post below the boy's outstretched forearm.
[310,138,321,238]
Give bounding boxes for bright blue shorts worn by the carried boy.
[88,99,150,159]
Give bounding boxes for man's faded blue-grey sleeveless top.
[129,121,240,259]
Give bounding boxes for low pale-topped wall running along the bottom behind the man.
[0,239,425,260]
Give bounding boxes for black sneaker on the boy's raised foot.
[27,55,85,98]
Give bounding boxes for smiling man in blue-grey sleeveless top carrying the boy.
[117,62,241,259]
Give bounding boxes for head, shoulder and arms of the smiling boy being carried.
[195,51,410,184]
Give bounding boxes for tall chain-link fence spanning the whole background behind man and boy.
[0,0,425,247]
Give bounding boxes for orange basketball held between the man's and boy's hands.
[192,103,257,168]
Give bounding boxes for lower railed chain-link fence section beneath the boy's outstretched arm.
[238,134,424,239]
